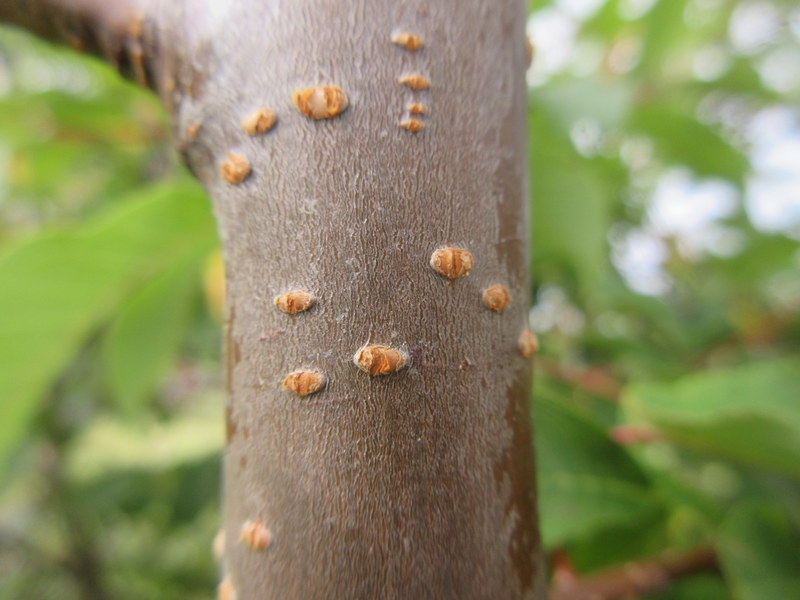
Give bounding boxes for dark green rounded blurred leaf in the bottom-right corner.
[717,505,800,600]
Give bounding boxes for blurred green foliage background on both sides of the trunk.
[0,0,800,600]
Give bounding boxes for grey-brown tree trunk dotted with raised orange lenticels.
[0,0,545,600]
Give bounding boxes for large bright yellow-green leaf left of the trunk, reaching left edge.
[0,182,214,472]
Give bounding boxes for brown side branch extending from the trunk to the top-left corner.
[0,0,157,88]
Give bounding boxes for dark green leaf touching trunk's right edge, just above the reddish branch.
[536,397,661,547]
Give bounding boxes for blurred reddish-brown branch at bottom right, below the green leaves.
[549,548,717,600]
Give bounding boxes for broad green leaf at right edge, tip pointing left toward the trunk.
[623,358,800,477]
